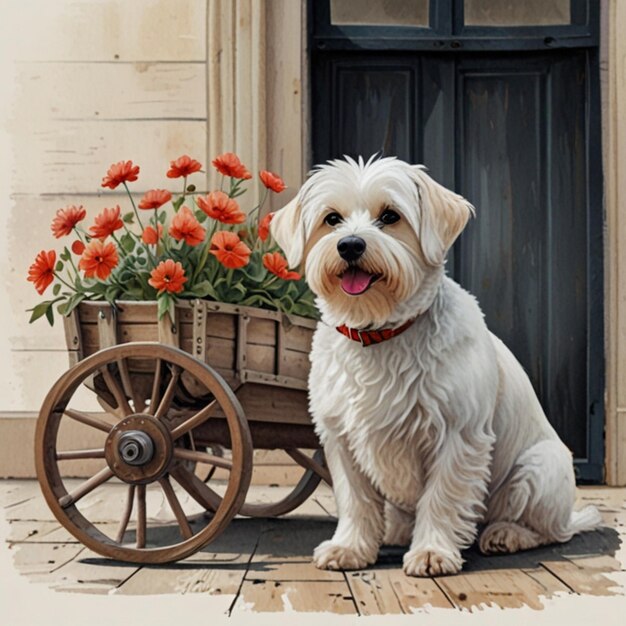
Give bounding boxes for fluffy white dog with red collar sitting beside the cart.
[271,158,601,576]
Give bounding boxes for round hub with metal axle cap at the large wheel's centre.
[104,413,173,484]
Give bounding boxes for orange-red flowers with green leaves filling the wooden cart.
[28,153,317,324]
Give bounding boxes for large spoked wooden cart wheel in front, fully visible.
[35,343,252,563]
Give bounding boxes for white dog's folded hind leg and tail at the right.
[479,439,602,553]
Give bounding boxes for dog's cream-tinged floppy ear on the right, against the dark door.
[412,165,474,266]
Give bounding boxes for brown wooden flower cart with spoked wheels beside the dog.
[35,300,330,563]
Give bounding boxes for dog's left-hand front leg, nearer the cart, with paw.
[313,440,384,569]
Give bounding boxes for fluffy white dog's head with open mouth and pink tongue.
[271,157,473,327]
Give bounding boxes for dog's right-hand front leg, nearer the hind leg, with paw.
[404,432,493,576]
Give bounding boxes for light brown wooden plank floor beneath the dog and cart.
[0,480,626,615]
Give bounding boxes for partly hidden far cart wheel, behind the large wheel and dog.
[191,448,332,517]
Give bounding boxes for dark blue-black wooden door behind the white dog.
[311,0,604,482]
